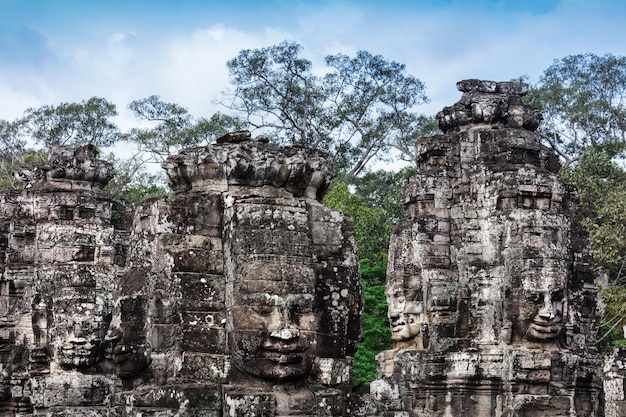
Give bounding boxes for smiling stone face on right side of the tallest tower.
[515,266,567,342]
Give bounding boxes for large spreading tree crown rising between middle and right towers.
[222,41,427,175]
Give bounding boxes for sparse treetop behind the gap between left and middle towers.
[124,95,243,162]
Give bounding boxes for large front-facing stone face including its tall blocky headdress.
[228,199,320,381]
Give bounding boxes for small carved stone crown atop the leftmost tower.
[15,145,115,190]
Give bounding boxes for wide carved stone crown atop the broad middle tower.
[162,131,335,201]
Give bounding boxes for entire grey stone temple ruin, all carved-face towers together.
[0,80,626,417]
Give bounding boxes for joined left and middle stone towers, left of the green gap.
[0,132,362,417]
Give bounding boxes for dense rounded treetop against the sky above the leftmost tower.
[22,97,122,149]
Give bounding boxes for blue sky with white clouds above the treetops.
[0,0,626,146]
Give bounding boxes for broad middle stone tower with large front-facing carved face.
[108,132,362,416]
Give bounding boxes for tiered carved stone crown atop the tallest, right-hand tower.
[436,79,542,133]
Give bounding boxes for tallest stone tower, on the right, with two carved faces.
[370,80,601,417]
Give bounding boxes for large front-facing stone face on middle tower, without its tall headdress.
[229,257,319,381]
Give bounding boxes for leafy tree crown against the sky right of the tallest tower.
[527,53,626,165]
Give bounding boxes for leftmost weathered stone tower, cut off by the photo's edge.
[0,147,129,415]
